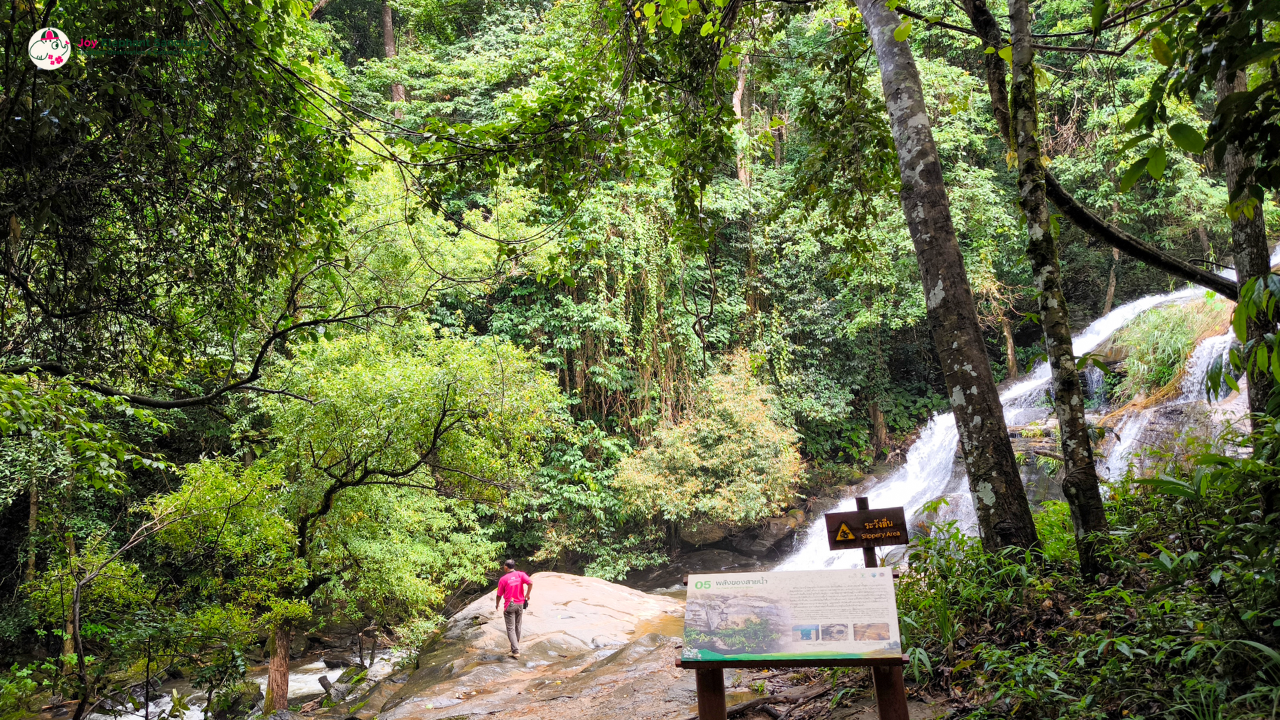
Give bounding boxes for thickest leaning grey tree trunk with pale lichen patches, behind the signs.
[856,0,1039,550]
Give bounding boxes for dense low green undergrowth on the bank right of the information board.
[899,421,1280,720]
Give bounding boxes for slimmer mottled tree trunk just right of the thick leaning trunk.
[1009,0,1107,578]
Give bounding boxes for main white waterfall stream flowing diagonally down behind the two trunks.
[777,287,1207,570]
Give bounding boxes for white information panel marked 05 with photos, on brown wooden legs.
[682,568,902,667]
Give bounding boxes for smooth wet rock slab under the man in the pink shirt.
[371,573,696,720]
